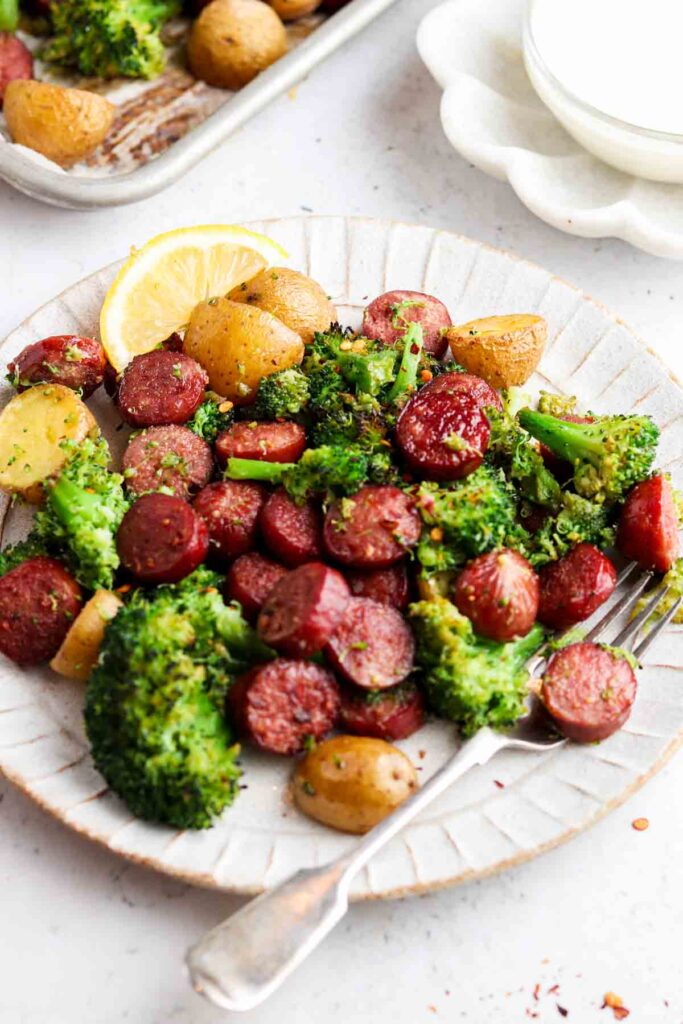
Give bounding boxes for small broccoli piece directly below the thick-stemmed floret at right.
[527,490,615,567]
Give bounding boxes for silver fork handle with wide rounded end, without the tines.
[187,728,506,1011]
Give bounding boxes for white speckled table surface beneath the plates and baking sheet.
[0,0,683,1024]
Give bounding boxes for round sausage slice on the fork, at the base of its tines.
[541,643,637,743]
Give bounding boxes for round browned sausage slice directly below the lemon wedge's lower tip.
[118,348,209,427]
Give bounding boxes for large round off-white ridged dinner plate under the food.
[0,217,683,898]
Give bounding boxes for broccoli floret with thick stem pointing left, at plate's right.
[519,409,659,502]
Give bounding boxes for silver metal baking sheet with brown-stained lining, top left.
[0,0,395,210]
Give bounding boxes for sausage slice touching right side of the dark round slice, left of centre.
[194,480,266,561]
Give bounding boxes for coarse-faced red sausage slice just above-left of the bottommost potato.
[227,657,339,755]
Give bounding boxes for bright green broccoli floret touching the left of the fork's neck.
[410,598,544,736]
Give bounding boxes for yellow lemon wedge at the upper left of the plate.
[99,224,287,372]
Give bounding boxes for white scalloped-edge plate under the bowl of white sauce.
[418,0,683,259]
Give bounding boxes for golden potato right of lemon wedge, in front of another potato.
[183,298,303,406]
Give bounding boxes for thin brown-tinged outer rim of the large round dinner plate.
[0,214,683,902]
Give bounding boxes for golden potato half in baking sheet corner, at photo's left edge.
[4,80,116,167]
